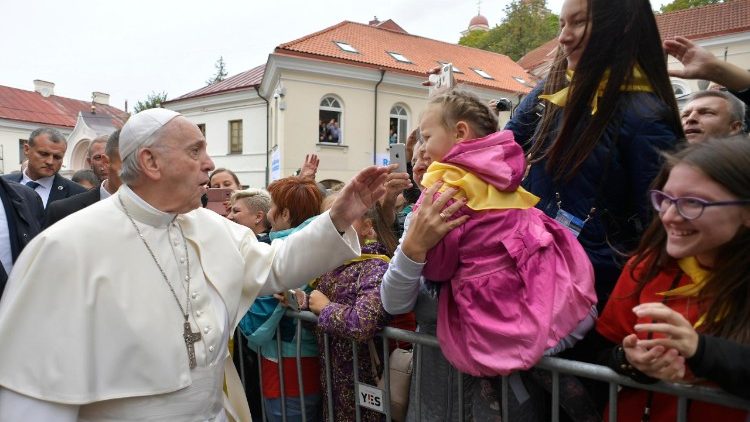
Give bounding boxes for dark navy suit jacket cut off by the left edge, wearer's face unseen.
[0,178,44,296]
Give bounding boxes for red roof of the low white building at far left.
[0,85,128,128]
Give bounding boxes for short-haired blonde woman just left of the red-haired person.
[232,189,271,243]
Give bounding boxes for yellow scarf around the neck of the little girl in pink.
[422,161,539,211]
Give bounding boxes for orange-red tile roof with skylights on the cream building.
[275,21,530,93]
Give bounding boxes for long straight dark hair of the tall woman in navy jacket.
[529,0,682,181]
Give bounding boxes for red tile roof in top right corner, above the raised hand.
[656,0,750,40]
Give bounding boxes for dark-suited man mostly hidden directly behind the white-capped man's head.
[44,130,122,228]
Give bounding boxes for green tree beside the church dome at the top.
[458,0,559,61]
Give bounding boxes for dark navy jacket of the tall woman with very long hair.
[505,82,678,306]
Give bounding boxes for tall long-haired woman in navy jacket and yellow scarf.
[505,0,683,309]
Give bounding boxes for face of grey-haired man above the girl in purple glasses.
[681,97,742,144]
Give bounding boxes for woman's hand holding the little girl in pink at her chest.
[401,181,469,262]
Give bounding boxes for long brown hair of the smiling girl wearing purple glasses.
[626,135,750,344]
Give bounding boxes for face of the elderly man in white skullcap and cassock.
[152,117,214,214]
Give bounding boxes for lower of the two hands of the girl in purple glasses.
[622,334,685,381]
